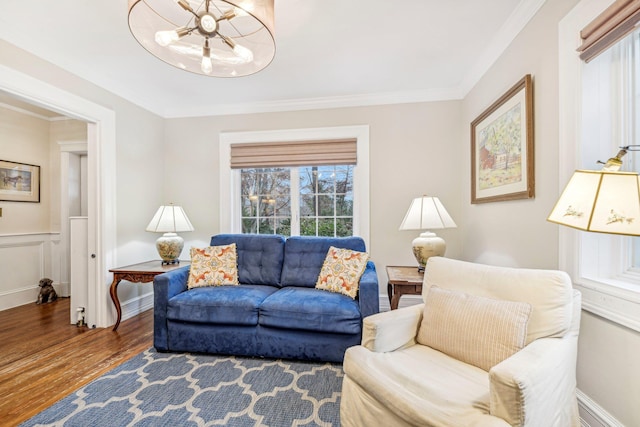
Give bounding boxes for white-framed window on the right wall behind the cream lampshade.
[559,2,640,331]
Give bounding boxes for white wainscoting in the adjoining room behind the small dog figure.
[0,233,60,310]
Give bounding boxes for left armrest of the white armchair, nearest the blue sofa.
[362,304,424,353]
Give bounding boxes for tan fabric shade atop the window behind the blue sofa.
[231,138,357,169]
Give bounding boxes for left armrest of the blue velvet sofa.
[153,265,189,351]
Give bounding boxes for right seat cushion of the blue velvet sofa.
[260,286,361,334]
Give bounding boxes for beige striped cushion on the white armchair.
[417,286,531,371]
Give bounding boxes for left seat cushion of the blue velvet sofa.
[167,285,279,325]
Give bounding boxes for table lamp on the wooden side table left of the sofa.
[146,204,193,265]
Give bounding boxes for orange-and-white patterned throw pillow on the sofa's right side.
[316,246,369,299]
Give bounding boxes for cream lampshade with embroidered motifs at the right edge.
[547,170,640,236]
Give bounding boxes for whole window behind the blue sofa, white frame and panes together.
[220,126,369,245]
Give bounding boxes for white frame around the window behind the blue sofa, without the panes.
[219,125,370,247]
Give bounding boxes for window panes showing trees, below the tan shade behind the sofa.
[240,165,354,237]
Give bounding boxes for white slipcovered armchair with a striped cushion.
[340,257,581,427]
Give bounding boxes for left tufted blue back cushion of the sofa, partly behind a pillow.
[211,234,285,285]
